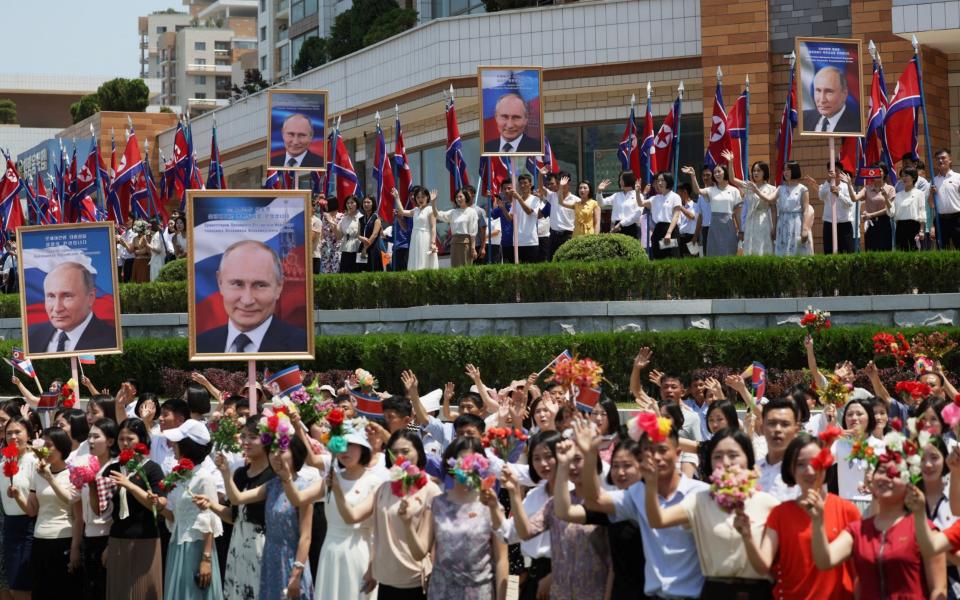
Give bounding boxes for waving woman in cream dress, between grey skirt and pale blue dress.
[723,150,777,256]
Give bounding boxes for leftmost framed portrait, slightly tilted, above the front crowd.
[17,222,123,358]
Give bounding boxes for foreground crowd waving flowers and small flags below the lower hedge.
[0,338,960,600]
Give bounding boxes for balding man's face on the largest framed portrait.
[217,244,283,331]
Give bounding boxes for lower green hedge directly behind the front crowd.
[0,327,960,399]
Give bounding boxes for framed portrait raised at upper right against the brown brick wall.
[796,37,866,137]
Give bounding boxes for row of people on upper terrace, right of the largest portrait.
[312,149,960,274]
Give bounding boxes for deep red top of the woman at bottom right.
[847,515,927,600]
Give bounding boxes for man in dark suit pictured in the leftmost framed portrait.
[27,262,117,354]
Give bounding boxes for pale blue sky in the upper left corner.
[0,0,187,77]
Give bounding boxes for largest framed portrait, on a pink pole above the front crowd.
[187,190,314,360]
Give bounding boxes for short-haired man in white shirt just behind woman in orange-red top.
[748,398,800,502]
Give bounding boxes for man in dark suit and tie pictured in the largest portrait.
[197,240,309,354]
